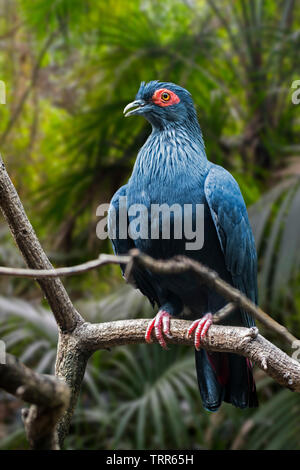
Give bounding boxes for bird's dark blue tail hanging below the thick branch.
[195,349,258,411]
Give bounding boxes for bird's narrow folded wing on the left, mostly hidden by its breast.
[107,185,159,305]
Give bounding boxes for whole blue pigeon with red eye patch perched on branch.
[107,80,258,411]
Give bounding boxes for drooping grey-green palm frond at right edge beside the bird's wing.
[249,177,300,326]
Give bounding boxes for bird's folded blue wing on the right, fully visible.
[204,165,257,327]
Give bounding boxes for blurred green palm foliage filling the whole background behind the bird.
[0,0,300,449]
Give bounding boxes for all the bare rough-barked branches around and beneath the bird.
[0,151,300,448]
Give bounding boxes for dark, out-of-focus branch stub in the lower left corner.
[0,354,70,450]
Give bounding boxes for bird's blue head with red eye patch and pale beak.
[124,80,198,129]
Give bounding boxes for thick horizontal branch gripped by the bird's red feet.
[75,318,300,392]
